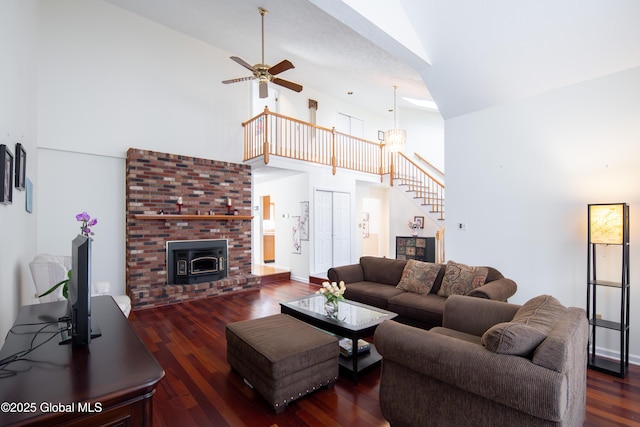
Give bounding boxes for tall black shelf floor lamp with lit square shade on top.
[587,203,630,378]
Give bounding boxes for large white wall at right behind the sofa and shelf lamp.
[445,68,640,363]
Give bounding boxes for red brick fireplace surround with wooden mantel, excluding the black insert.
[126,148,260,308]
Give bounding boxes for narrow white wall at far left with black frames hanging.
[0,0,38,344]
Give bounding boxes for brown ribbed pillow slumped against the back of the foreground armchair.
[482,295,567,357]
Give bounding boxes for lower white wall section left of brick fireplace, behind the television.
[37,148,125,295]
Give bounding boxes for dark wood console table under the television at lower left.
[0,295,164,426]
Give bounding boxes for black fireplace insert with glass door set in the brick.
[167,239,227,285]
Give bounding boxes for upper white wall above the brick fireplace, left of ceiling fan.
[38,0,250,161]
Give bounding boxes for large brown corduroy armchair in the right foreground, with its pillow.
[374,295,588,427]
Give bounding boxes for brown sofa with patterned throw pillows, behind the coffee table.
[328,256,517,329]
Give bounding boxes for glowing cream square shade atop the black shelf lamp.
[589,203,625,245]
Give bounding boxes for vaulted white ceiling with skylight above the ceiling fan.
[106,0,640,118]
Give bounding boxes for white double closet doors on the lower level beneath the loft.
[314,190,351,273]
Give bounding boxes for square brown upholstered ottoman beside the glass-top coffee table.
[226,314,340,413]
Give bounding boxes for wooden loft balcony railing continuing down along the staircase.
[242,107,444,219]
